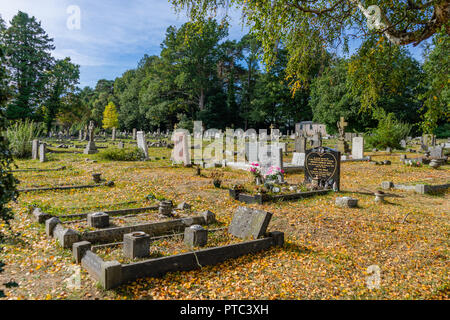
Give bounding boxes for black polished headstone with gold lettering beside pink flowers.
[305,147,341,191]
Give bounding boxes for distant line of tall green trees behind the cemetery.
[0,12,449,133]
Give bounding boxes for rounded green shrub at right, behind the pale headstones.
[366,112,411,149]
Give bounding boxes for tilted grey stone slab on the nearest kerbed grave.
[228,207,272,239]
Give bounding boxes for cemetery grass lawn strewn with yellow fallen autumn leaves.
[0,148,450,299]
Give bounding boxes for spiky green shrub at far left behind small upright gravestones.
[6,120,42,158]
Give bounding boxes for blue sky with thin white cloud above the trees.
[0,0,428,87]
